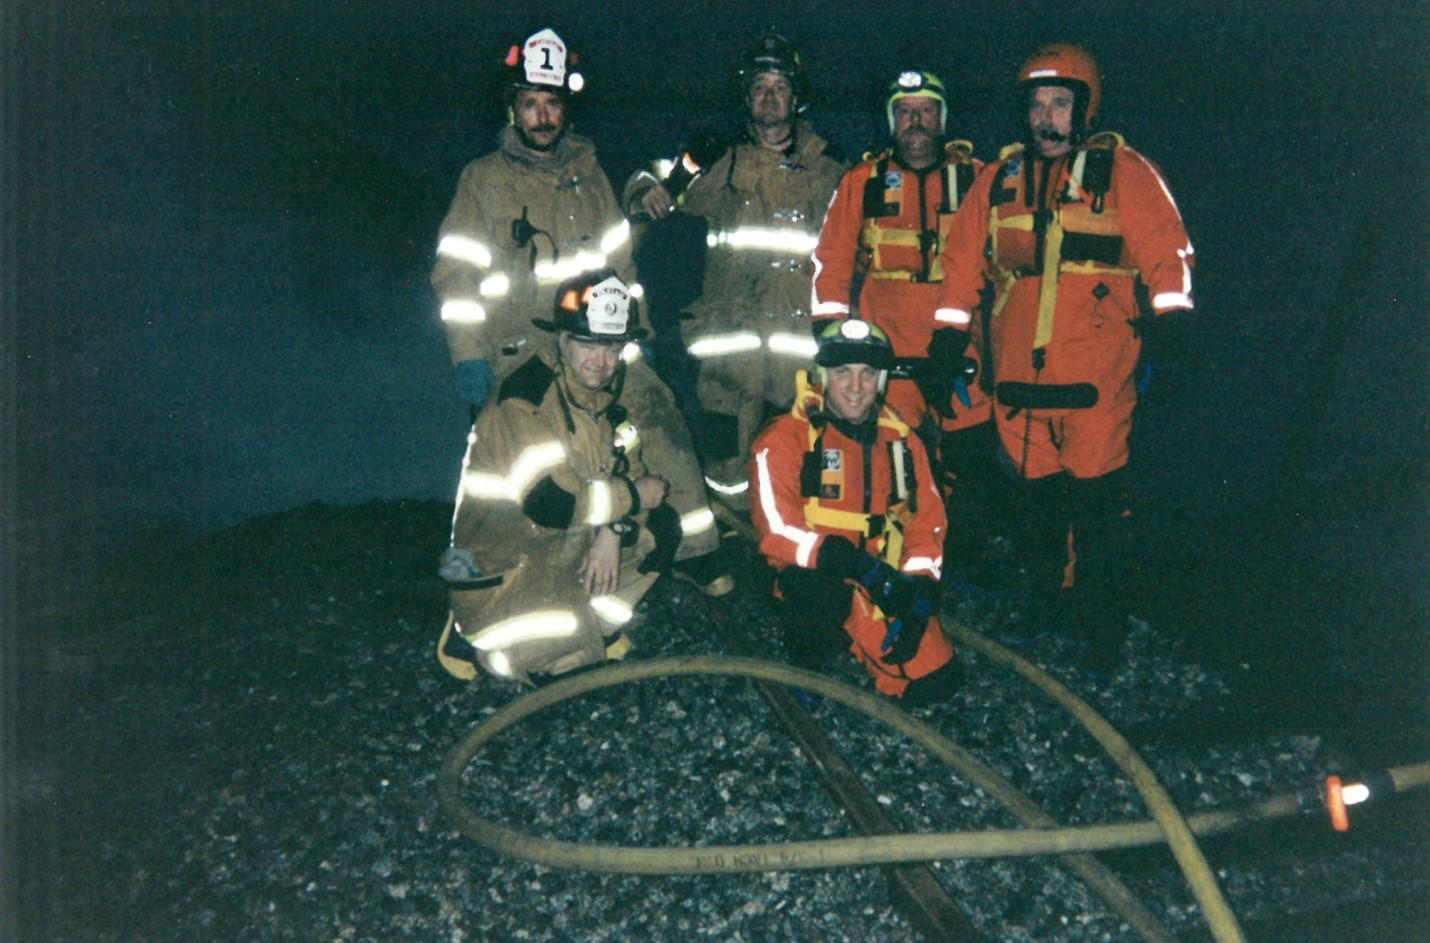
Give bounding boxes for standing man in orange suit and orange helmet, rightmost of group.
[937,43,1193,671]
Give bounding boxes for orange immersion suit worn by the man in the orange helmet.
[937,132,1193,479]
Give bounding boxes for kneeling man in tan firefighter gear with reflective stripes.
[439,269,681,681]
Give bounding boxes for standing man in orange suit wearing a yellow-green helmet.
[811,70,1005,567]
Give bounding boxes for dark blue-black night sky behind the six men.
[3,0,1430,547]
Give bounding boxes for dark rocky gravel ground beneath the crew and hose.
[6,502,1430,943]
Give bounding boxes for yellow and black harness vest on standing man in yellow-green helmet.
[859,140,974,282]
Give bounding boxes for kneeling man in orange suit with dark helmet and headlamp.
[749,319,954,703]
